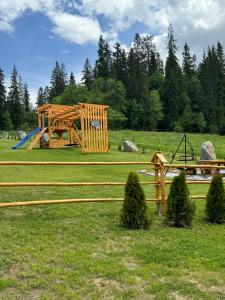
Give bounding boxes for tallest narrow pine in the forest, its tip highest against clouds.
[162,25,184,129]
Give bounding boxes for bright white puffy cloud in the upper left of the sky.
[0,0,102,44]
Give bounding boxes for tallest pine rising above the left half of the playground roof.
[49,61,67,101]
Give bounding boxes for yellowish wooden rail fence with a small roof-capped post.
[0,151,225,213]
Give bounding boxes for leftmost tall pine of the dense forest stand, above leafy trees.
[95,35,112,79]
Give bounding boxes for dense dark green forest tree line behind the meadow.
[0,25,225,134]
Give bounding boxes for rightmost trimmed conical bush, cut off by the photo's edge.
[205,174,225,224]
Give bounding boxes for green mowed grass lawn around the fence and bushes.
[0,131,225,299]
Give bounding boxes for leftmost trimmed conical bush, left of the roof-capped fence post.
[120,172,150,229]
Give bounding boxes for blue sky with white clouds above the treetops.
[0,0,225,103]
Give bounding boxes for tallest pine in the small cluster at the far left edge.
[7,66,24,129]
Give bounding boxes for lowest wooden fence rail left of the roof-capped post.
[0,198,157,207]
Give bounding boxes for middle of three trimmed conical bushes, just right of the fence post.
[166,172,196,227]
